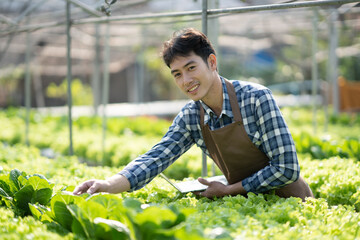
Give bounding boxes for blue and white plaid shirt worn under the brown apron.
[119,78,300,193]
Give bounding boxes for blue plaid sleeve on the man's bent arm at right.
[242,89,300,193]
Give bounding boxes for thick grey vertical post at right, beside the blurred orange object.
[328,8,340,115]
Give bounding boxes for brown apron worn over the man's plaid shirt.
[200,80,313,200]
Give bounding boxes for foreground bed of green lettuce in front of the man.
[0,144,360,239]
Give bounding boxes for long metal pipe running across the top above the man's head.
[0,0,360,36]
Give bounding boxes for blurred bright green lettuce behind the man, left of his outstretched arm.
[0,110,170,166]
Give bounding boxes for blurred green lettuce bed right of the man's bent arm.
[282,108,360,160]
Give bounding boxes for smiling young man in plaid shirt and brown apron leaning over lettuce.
[74,28,313,200]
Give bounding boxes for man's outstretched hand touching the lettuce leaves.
[73,175,130,195]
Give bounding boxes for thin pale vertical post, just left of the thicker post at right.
[311,7,319,133]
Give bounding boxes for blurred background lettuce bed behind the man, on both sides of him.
[0,109,360,175]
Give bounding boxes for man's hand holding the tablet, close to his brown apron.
[194,178,246,198]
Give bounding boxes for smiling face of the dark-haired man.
[170,53,217,101]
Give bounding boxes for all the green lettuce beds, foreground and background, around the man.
[0,109,360,240]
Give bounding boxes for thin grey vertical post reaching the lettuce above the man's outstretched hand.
[102,23,110,165]
